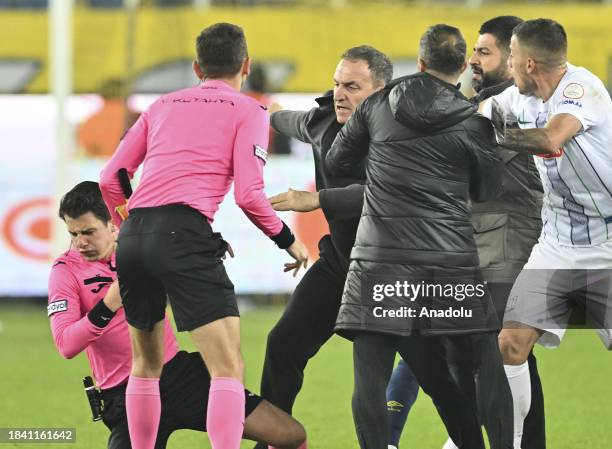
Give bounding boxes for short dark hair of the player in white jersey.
[512,19,567,66]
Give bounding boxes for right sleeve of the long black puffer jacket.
[467,115,504,203]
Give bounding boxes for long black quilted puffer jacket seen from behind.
[326,73,503,335]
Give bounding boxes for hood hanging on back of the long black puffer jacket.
[388,73,478,132]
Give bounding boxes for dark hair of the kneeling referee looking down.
[59,181,111,223]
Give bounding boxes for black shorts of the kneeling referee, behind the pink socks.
[102,351,263,449]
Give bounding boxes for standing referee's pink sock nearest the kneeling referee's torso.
[125,376,161,449]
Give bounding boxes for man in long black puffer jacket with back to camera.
[326,25,504,449]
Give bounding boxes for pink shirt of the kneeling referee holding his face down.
[47,249,178,388]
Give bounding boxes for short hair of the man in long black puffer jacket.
[419,23,467,75]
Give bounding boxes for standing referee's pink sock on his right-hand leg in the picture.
[206,377,244,449]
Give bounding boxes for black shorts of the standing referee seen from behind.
[117,204,239,331]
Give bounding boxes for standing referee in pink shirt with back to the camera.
[100,23,307,449]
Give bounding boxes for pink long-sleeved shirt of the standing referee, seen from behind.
[100,80,283,236]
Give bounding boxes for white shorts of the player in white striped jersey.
[504,237,612,350]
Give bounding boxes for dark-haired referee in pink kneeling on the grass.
[47,181,306,449]
